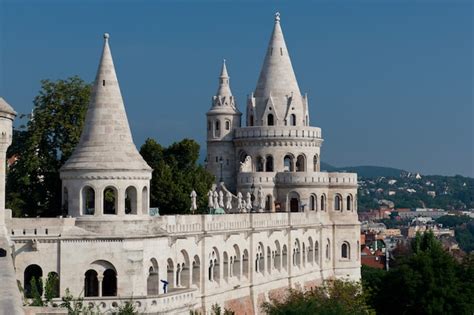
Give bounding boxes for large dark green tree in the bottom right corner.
[376,232,474,314]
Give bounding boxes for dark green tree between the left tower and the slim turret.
[140,139,214,214]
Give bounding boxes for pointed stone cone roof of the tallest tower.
[253,12,304,124]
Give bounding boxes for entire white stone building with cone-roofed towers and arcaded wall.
[0,15,360,314]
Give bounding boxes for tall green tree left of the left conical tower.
[6,77,91,216]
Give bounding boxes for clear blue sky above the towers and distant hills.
[0,0,474,177]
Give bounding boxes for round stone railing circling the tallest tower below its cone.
[234,126,321,140]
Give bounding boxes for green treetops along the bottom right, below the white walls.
[262,232,474,315]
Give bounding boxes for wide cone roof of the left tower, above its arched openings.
[61,33,151,171]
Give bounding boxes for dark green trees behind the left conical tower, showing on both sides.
[6,77,214,217]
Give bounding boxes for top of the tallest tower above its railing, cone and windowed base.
[247,12,309,126]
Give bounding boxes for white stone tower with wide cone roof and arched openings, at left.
[60,34,152,218]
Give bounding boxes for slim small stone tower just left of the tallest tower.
[206,60,242,190]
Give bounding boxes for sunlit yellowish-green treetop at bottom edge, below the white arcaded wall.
[262,280,375,315]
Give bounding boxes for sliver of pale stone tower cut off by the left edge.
[0,97,16,235]
